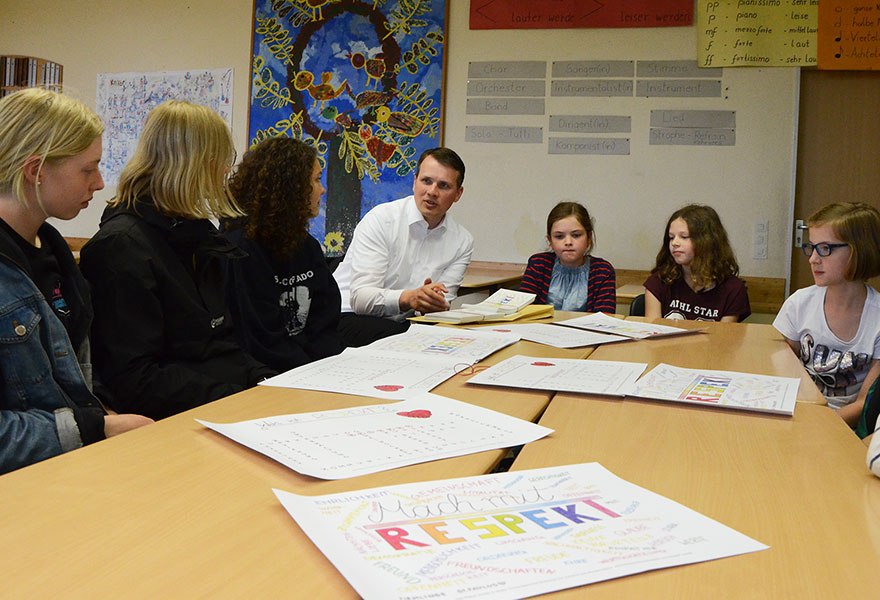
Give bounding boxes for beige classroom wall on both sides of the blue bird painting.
[0,0,797,286]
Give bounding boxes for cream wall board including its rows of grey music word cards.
[445,6,799,277]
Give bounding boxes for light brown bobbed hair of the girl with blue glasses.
[807,202,880,281]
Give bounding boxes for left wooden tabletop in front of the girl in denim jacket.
[0,342,589,599]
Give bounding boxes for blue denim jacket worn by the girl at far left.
[0,225,104,473]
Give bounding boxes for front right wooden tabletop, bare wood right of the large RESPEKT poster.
[513,394,880,600]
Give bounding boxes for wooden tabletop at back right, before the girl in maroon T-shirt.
[590,317,825,404]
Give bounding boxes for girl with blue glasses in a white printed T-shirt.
[773,202,880,429]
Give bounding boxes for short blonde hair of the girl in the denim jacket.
[0,88,104,202]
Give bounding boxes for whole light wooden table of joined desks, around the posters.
[0,315,880,598]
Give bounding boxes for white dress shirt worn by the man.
[333,196,474,319]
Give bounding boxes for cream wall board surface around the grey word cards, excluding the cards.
[444,8,799,277]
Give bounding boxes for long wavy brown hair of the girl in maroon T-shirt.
[651,204,739,289]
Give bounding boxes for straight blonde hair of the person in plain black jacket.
[110,100,243,219]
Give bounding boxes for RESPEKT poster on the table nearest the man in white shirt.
[361,323,519,365]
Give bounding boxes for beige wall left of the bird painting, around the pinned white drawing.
[0,0,253,237]
